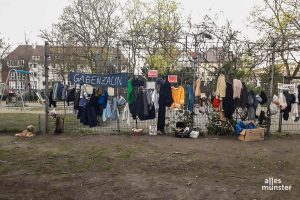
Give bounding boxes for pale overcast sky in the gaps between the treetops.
[0,0,261,47]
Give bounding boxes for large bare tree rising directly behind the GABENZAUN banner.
[42,0,122,73]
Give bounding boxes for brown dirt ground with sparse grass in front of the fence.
[0,135,300,200]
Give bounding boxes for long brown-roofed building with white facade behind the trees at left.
[1,45,128,90]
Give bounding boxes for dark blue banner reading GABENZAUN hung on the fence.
[69,72,128,87]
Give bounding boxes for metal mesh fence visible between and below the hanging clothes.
[0,71,300,134]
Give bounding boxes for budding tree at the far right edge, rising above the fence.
[250,0,300,77]
